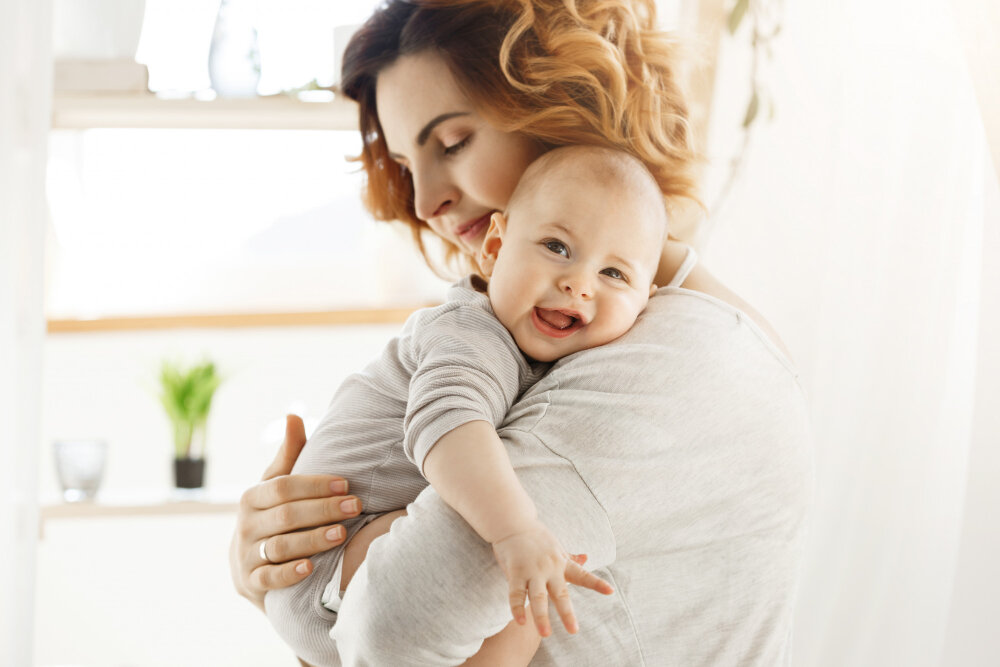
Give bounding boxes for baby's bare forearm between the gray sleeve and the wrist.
[424,421,538,544]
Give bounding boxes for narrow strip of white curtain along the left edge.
[0,0,52,666]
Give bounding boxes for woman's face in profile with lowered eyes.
[375,51,542,255]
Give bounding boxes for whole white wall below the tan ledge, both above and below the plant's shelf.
[35,325,399,667]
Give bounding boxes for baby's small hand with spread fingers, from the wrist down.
[493,523,614,637]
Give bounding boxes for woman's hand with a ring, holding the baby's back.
[229,415,361,611]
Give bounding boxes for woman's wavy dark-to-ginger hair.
[341,0,698,270]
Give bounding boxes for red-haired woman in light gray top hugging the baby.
[231,0,811,665]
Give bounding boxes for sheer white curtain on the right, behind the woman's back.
[705,0,1000,667]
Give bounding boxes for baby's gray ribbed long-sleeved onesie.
[264,277,549,667]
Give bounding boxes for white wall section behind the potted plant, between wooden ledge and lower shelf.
[40,325,401,497]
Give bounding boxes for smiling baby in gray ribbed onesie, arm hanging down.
[265,146,667,667]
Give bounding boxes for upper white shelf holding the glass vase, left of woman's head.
[52,93,358,131]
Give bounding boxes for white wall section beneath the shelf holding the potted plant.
[37,515,298,667]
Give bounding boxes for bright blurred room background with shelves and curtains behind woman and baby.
[0,0,1000,667]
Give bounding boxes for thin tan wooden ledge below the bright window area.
[46,304,435,334]
